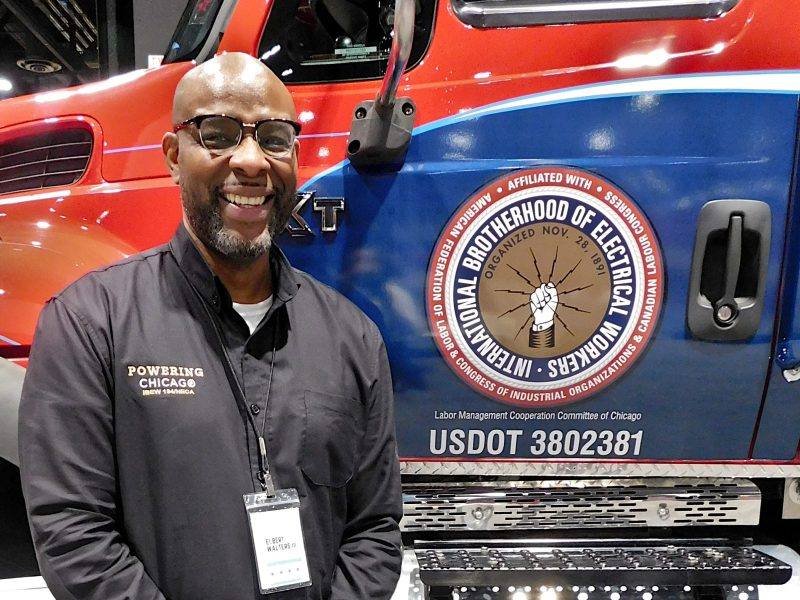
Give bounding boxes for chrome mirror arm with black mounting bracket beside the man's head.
[347,0,417,167]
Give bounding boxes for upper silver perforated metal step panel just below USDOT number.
[400,479,761,531]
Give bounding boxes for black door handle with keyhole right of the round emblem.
[686,200,771,342]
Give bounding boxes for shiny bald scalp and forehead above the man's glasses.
[172,52,295,124]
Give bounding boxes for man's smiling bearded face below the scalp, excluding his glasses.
[170,81,297,262]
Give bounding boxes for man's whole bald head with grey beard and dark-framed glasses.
[161,53,300,268]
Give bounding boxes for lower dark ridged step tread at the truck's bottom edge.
[414,538,792,587]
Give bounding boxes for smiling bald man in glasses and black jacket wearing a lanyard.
[20,54,401,600]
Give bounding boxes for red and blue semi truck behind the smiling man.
[0,0,800,600]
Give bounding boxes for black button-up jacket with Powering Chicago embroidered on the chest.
[20,227,401,600]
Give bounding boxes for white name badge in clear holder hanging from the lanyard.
[244,489,311,594]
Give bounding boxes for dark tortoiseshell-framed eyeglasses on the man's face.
[173,115,300,158]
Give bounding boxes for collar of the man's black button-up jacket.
[169,223,300,312]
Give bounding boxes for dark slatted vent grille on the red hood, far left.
[0,127,92,194]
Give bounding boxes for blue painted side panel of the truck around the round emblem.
[282,76,797,460]
